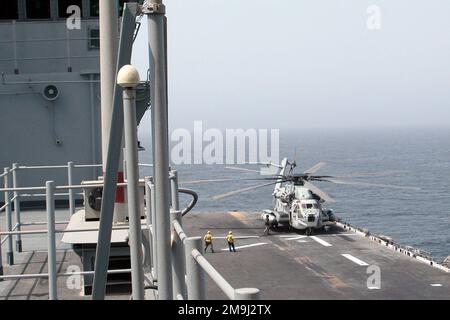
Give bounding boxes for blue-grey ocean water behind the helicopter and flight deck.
[140,128,450,260]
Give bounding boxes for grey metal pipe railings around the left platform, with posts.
[0,162,259,300]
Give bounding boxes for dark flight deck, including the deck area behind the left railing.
[0,211,450,300]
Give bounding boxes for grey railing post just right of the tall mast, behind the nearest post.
[170,211,186,299]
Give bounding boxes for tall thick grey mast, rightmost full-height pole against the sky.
[144,0,173,300]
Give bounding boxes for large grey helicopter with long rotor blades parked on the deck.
[182,158,420,235]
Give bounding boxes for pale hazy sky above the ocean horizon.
[133,0,450,129]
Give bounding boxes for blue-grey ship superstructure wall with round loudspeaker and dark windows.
[0,0,148,202]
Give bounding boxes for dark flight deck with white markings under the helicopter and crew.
[184,212,450,300]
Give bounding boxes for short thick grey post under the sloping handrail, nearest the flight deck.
[185,237,205,300]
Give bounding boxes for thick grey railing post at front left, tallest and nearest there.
[45,181,58,300]
